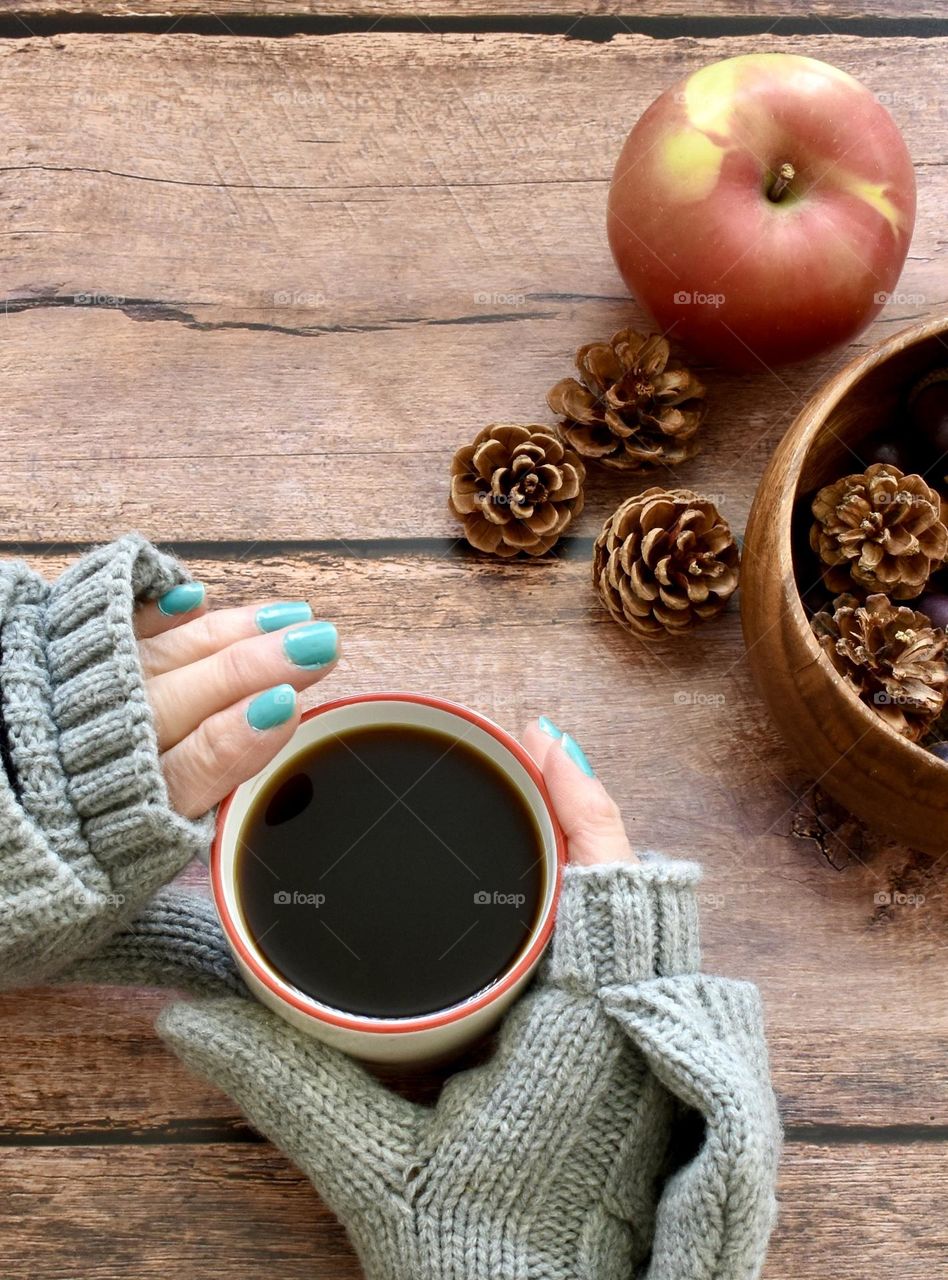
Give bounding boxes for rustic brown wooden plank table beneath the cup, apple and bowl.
[0,0,948,1280]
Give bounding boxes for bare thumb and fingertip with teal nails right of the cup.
[523,716,638,867]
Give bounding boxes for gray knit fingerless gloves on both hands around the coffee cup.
[0,539,779,1280]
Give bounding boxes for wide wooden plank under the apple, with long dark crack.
[0,35,948,540]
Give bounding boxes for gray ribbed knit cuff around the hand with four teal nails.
[0,535,210,987]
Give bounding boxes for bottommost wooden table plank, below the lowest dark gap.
[0,1143,948,1280]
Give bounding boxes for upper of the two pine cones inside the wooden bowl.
[810,462,948,600]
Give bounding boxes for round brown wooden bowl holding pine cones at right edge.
[741,316,948,854]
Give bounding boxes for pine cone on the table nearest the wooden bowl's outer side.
[592,488,739,636]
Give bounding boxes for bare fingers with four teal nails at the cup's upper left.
[136,582,339,818]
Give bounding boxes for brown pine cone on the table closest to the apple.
[546,329,705,471]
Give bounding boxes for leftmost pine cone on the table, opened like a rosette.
[449,425,586,556]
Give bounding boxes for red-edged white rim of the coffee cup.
[209,692,567,1036]
